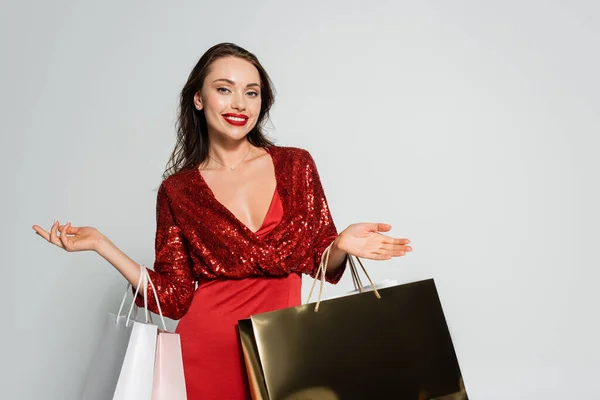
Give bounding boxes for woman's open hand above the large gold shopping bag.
[336,223,412,260]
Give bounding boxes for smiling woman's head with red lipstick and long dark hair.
[164,43,275,178]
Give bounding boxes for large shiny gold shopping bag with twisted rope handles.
[238,248,467,400]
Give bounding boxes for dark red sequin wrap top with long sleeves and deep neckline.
[136,146,344,319]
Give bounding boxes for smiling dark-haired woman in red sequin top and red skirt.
[33,43,412,400]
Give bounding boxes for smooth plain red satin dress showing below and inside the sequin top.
[177,192,302,400]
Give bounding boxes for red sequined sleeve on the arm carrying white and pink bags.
[136,182,194,319]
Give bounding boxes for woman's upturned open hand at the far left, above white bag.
[33,221,105,252]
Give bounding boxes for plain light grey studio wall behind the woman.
[0,0,600,400]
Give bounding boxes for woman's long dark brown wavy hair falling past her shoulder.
[163,43,275,179]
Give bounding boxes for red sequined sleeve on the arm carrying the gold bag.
[296,152,346,284]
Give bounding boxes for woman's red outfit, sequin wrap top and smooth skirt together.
[137,146,344,400]
